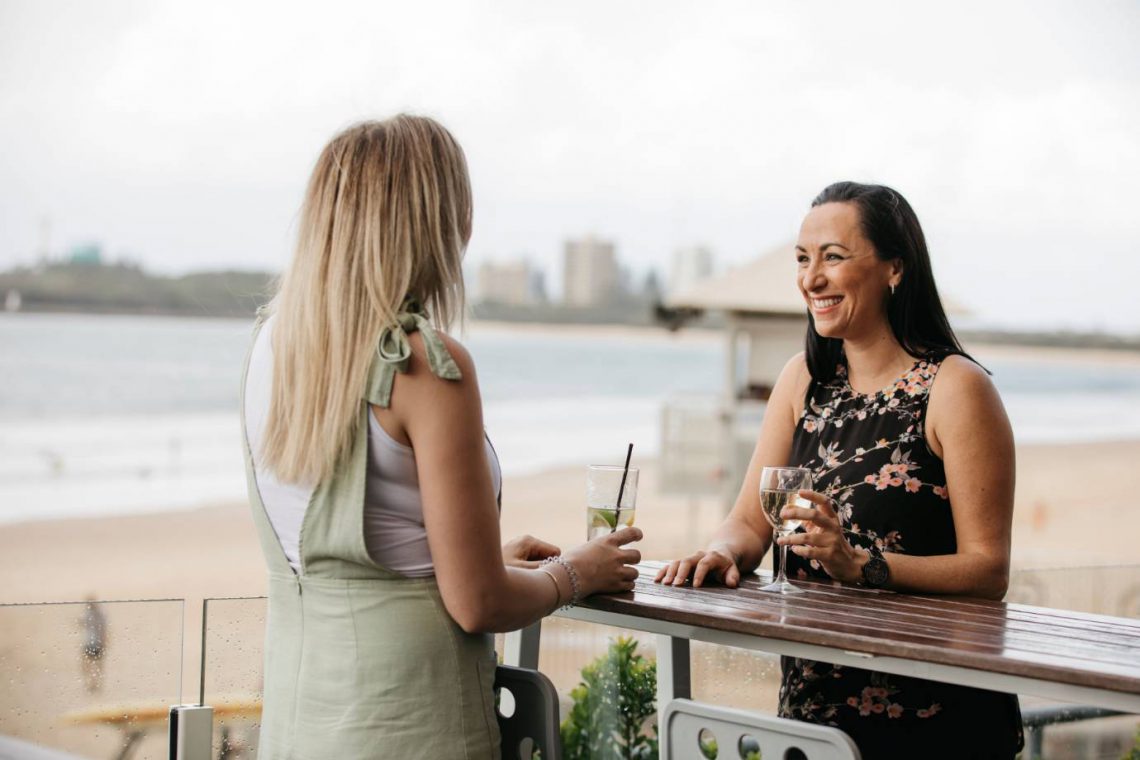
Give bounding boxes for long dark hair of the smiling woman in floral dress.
[805,182,974,383]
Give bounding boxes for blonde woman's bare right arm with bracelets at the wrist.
[374,335,641,631]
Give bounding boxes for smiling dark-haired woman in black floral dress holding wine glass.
[657,182,1021,758]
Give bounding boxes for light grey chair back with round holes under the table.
[661,700,860,760]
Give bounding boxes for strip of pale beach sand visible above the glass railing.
[0,441,1140,603]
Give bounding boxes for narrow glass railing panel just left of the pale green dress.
[201,597,268,760]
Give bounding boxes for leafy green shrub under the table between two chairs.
[561,637,659,760]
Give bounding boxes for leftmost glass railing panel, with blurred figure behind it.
[0,599,184,760]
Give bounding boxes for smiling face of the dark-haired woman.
[796,203,903,340]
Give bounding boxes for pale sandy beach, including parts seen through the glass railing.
[0,441,1140,757]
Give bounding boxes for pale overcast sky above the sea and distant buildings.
[0,0,1140,333]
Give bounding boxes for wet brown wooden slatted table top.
[580,562,1140,694]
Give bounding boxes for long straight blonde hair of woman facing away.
[261,114,471,483]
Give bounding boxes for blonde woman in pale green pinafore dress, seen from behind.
[243,115,641,760]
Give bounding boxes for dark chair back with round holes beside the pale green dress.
[495,665,562,760]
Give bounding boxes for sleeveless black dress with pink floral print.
[773,358,1023,758]
